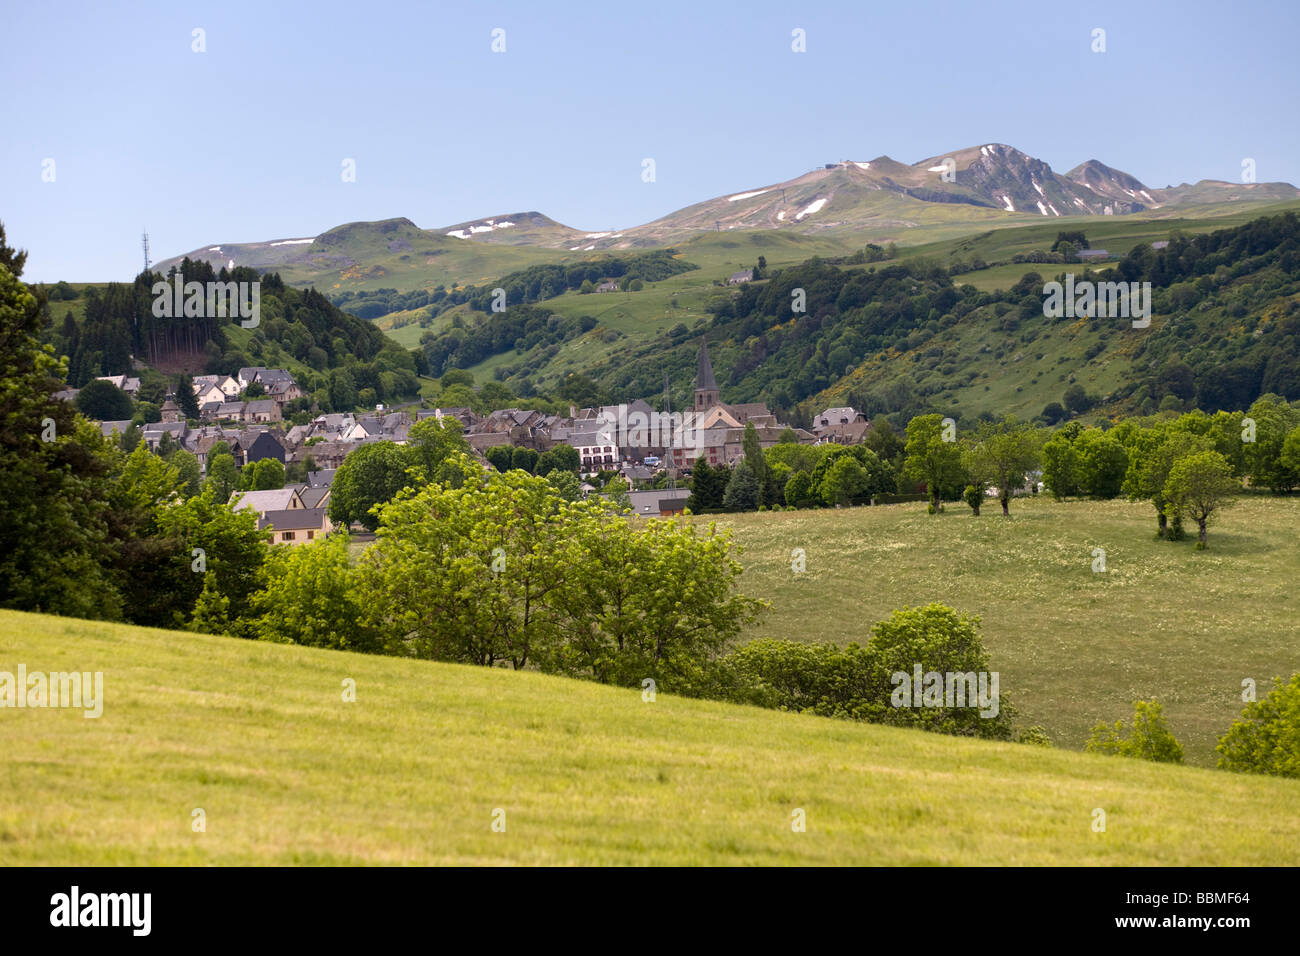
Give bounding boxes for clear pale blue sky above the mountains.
[0,0,1300,281]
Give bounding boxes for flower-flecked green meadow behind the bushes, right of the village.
[694,496,1300,766]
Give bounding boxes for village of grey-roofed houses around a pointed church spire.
[61,342,871,544]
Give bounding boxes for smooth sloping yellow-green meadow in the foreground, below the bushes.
[0,611,1300,865]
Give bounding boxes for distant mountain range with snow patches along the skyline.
[157,143,1300,281]
